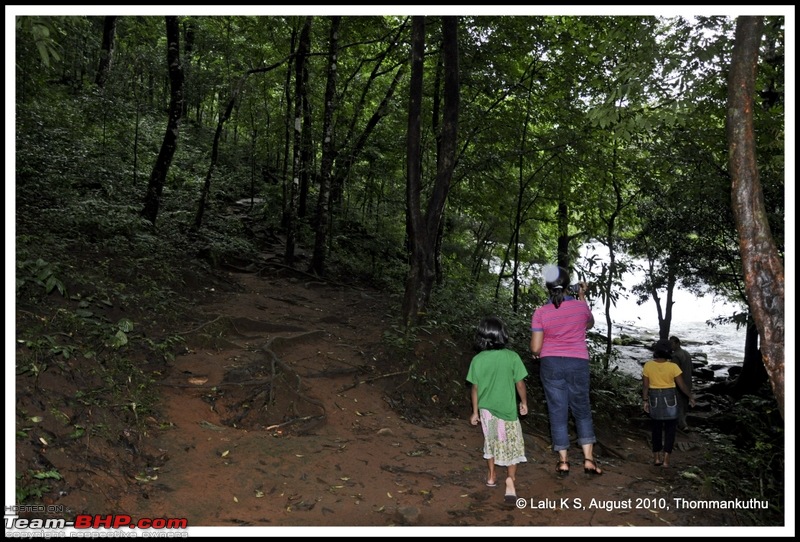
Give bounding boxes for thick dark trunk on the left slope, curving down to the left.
[141,16,183,225]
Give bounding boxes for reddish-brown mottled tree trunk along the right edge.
[726,16,785,416]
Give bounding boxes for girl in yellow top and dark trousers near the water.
[642,340,695,468]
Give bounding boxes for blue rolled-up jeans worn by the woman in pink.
[539,356,597,452]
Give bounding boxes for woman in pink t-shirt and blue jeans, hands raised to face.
[531,267,603,476]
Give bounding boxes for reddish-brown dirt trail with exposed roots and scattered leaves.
[56,272,734,534]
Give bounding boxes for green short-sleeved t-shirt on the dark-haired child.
[467,349,528,422]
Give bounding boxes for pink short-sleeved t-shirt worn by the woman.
[531,299,592,359]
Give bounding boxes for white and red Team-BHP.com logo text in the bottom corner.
[4,514,189,531]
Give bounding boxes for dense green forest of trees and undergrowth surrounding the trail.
[12,10,791,532]
